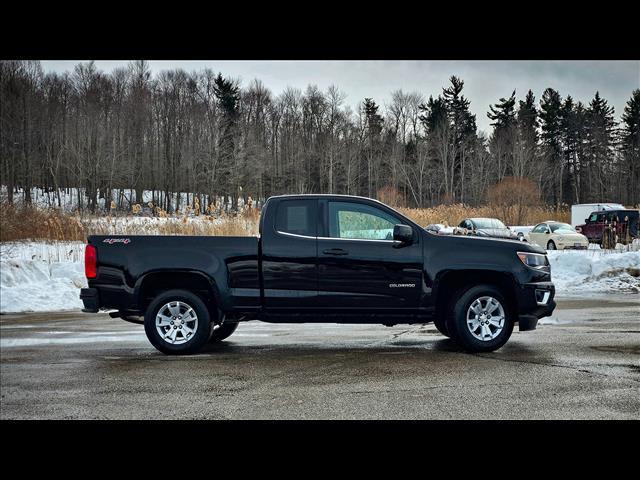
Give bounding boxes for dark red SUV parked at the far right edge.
[576,210,640,248]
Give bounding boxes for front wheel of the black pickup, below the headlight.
[447,285,514,352]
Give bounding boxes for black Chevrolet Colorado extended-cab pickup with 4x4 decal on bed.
[80,195,555,354]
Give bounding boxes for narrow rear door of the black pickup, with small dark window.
[262,199,318,310]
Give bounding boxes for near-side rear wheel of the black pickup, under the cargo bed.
[144,290,211,355]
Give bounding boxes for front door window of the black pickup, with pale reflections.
[329,202,402,240]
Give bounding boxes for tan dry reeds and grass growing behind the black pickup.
[0,203,570,242]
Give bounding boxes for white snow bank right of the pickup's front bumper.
[547,250,640,296]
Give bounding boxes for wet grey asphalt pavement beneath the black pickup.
[0,295,640,419]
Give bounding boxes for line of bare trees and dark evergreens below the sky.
[0,61,640,212]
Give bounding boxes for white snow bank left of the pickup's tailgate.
[0,242,87,313]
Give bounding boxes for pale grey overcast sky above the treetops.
[42,60,640,132]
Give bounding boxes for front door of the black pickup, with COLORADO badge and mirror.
[318,199,423,314]
